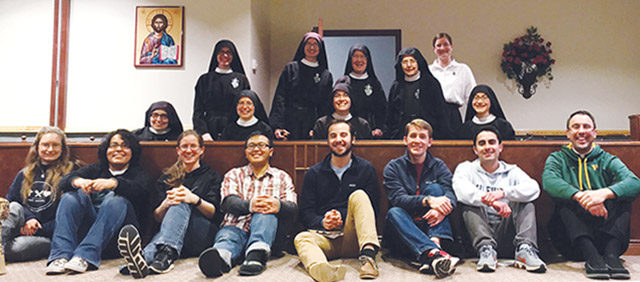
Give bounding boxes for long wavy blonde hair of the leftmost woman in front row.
[20,126,74,204]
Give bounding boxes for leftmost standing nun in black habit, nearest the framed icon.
[193,39,269,140]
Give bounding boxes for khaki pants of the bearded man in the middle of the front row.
[294,190,380,270]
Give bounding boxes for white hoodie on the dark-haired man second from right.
[453,159,540,207]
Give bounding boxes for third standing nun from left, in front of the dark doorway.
[336,44,387,137]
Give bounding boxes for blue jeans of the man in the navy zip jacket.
[384,207,453,259]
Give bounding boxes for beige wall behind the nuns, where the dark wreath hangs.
[270,0,640,130]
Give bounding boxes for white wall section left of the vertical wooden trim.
[0,0,53,130]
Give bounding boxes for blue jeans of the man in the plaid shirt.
[213,213,278,266]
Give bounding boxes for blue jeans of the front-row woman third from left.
[144,203,218,263]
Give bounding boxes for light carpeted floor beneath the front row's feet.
[0,254,640,282]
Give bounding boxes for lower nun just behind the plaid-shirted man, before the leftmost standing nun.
[220,90,274,141]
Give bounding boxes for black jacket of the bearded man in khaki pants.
[298,154,380,230]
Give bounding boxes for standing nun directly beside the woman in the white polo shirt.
[385,47,457,139]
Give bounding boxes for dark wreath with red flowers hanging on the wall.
[500,26,556,98]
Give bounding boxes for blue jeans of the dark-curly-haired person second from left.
[49,189,138,268]
